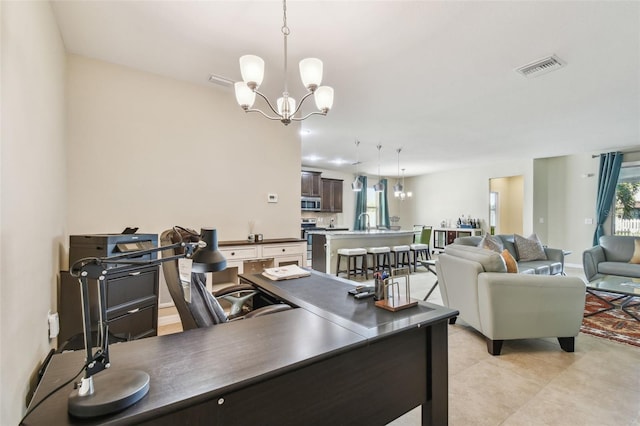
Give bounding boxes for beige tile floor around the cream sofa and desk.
[160,268,640,426]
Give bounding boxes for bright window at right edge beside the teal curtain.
[613,161,640,236]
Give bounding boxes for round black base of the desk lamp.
[69,369,149,418]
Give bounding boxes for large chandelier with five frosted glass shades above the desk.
[235,0,333,126]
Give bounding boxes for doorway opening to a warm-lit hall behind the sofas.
[489,175,524,235]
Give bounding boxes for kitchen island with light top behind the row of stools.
[309,229,415,274]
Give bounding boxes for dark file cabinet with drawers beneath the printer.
[58,266,159,350]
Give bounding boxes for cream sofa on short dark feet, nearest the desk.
[436,244,586,355]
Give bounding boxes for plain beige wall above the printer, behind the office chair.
[68,55,300,256]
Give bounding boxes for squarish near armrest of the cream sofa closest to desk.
[478,272,586,340]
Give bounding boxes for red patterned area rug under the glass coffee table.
[580,292,640,347]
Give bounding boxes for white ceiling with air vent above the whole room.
[53,0,640,176]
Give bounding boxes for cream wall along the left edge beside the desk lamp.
[0,1,66,425]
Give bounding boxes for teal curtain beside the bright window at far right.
[593,152,623,246]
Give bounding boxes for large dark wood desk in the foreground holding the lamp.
[24,272,457,425]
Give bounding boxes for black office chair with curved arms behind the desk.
[160,227,291,331]
